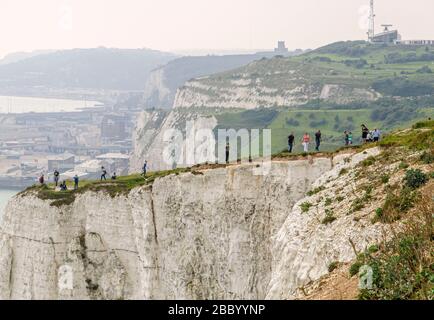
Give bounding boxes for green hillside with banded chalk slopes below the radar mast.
[175,41,434,109]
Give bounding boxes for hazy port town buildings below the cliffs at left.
[0,92,140,189]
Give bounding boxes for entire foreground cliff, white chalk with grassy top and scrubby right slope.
[0,121,434,300]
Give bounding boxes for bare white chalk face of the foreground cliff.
[0,149,386,299]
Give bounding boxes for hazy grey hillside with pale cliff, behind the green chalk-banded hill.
[143,51,306,109]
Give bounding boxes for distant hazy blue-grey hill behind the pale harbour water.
[0,48,176,93]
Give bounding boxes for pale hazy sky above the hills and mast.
[0,0,434,57]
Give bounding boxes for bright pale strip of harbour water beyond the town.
[0,96,101,114]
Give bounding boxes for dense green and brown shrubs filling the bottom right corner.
[358,188,434,300]
